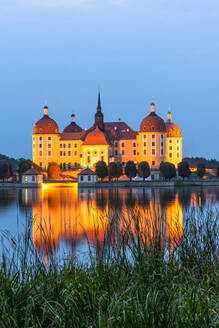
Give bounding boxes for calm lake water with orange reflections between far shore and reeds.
[0,187,219,259]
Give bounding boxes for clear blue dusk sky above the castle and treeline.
[0,0,219,160]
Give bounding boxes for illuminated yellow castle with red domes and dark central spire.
[32,93,182,170]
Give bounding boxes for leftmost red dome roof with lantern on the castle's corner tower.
[33,106,59,134]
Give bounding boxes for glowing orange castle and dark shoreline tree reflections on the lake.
[14,188,219,262]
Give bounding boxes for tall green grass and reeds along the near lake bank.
[0,209,219,328]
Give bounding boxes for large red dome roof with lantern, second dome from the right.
[140,102,166,132]
